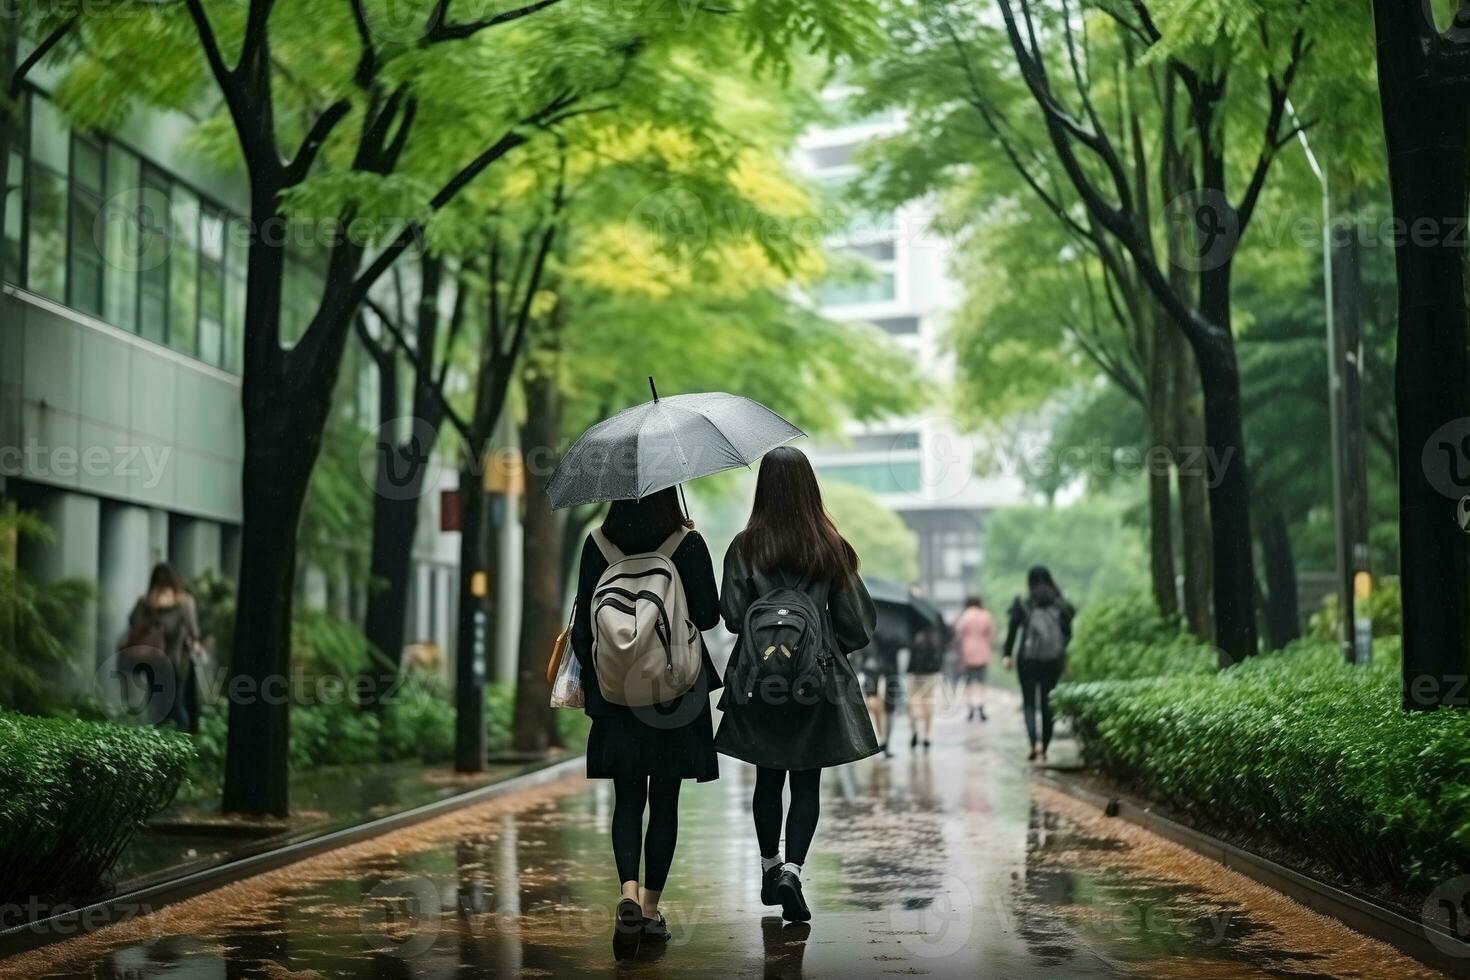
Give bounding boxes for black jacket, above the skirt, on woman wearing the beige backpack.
[572,527,720,718]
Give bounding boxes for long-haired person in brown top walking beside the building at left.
[118,561,198,733]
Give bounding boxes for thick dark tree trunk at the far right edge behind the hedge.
[1373,0,1470,710]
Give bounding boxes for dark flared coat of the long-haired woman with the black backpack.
[714,535,878,770]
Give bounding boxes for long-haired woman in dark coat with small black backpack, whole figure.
[714,447,878,923]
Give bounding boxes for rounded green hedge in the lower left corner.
[0,713,193,904]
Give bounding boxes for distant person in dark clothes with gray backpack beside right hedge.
[1004,564,1072,761]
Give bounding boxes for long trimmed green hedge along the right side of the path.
[1054,642,1470,887]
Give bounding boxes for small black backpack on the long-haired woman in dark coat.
[729,588,832,711]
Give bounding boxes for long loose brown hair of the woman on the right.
[739,445,858,582]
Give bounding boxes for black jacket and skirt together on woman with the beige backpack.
[572,529,722,780]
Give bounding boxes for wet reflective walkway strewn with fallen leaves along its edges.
[0,699,1439,980]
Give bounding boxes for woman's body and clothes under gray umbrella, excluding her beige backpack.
[572,488,720,959]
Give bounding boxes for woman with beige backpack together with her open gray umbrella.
[547,379,801,959]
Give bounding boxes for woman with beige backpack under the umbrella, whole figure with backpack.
[572,488,720,959]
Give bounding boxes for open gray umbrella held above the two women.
[547,379,806,510]
